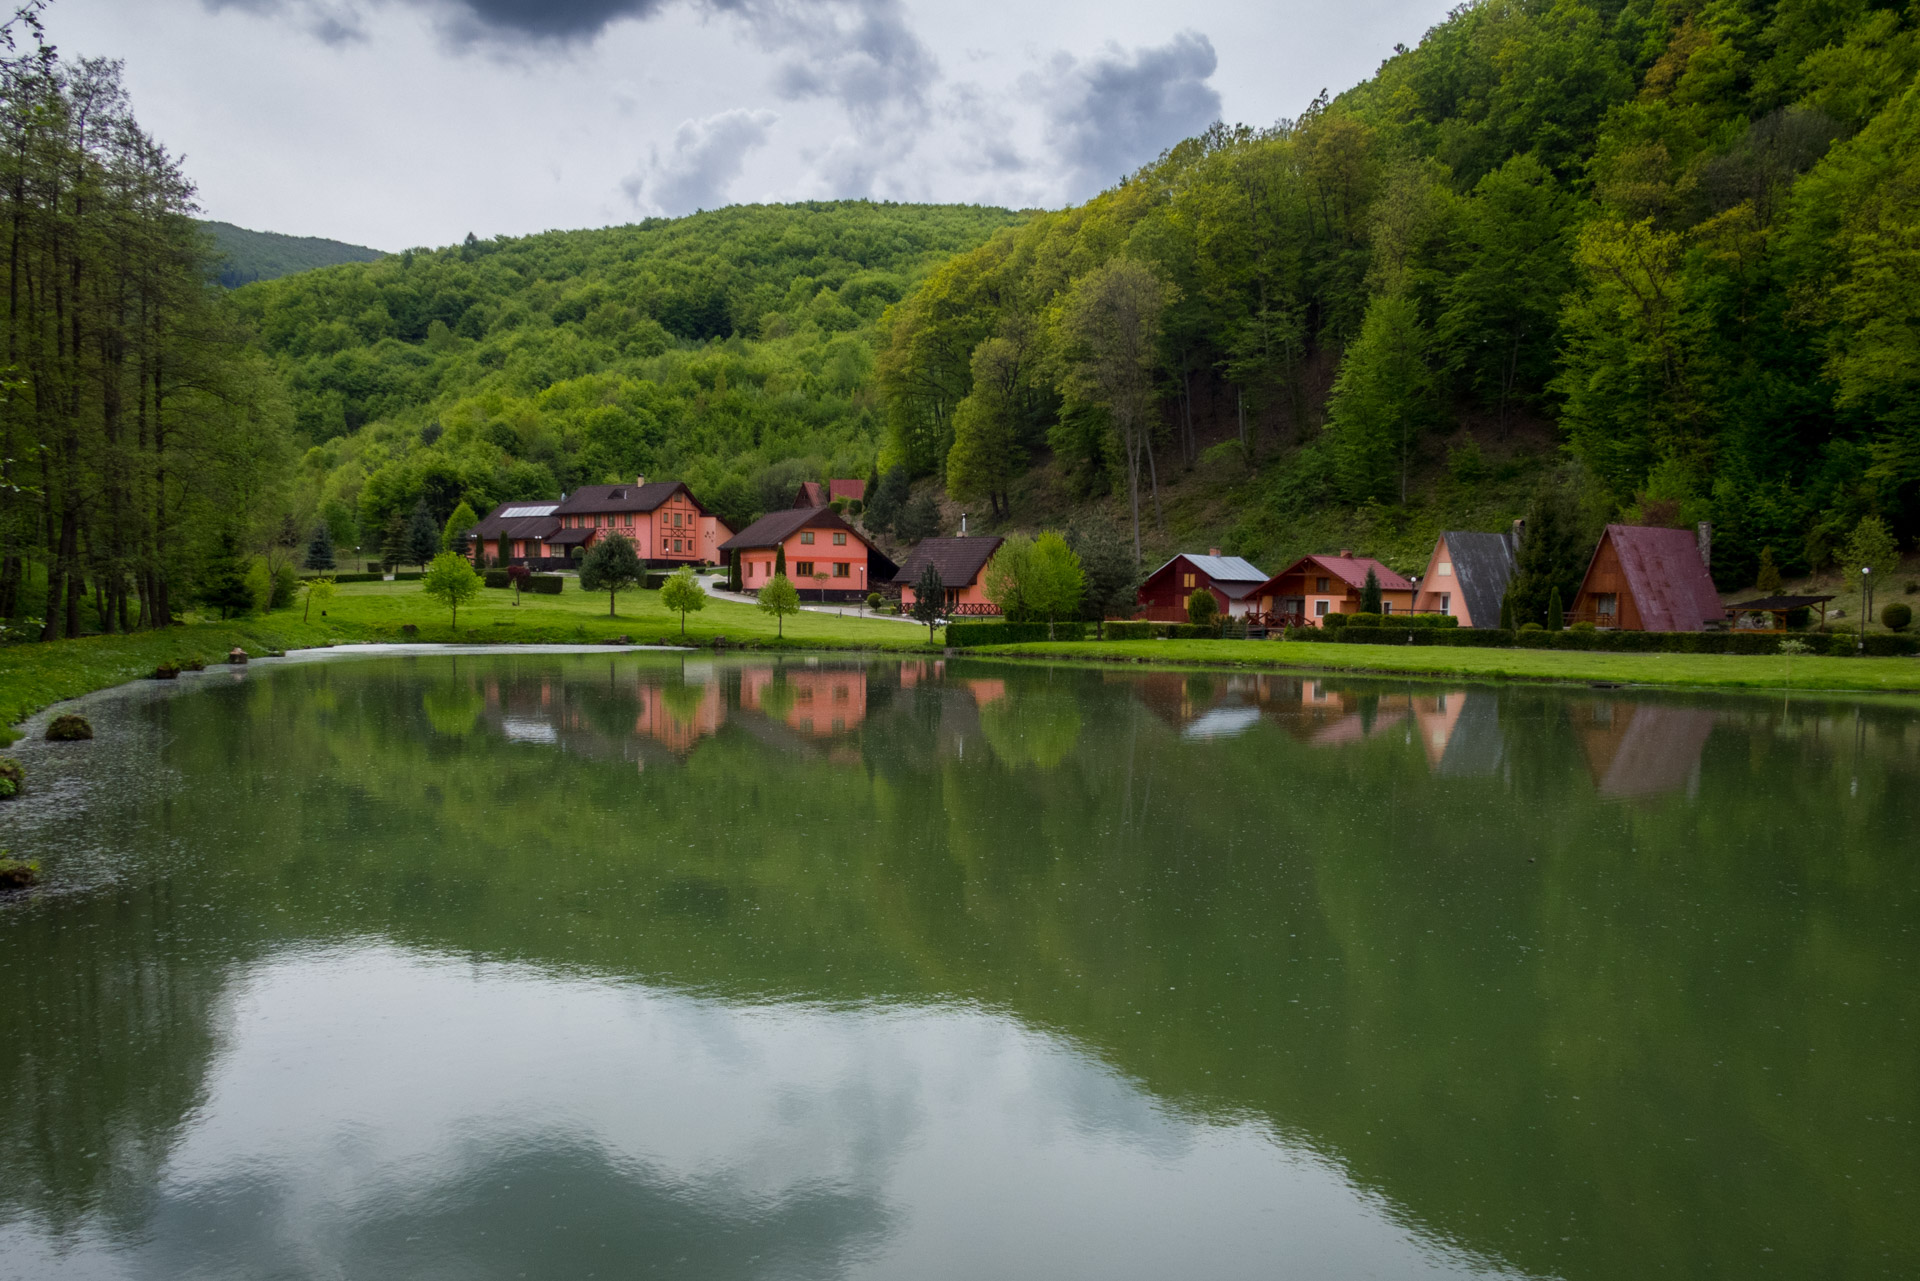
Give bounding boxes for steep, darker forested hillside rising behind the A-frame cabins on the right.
[879,0,1920,586]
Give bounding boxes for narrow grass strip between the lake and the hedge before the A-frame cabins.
[968,640,1920,693]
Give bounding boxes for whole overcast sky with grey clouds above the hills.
[48,0,1448,250]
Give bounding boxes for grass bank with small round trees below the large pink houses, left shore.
[0,582,927,743]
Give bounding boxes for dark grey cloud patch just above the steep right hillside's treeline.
[1041,31,1221,200]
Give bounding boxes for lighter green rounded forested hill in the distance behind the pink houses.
[236,202,1018,547]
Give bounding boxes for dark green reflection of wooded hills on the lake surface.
[0,659,1920,1277]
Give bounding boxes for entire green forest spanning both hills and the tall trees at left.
[0,0,1920,634]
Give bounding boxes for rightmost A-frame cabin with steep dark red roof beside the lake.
[1565,524,1726,632]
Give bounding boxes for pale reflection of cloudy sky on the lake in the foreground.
[0,945,1520,1277]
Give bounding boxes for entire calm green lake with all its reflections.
[0,651,1920,1281]
